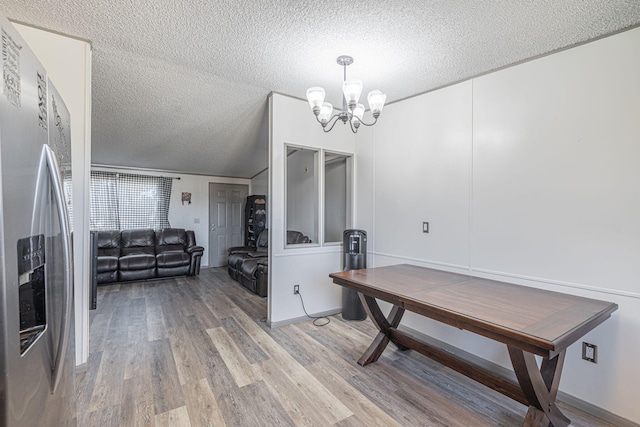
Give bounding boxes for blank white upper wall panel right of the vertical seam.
[471,30,640,294]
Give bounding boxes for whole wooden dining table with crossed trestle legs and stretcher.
[329,264,618,427]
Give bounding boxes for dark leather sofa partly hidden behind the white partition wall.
[227,229,311,297]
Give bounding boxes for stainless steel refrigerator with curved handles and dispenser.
[0,15,76,427]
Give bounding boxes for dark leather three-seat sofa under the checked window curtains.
[93,228,204,284]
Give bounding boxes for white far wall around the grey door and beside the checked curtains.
[92,166,253,267]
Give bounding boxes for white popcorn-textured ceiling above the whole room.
[0,0,640,177]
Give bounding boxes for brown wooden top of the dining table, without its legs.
[330,264,618,357]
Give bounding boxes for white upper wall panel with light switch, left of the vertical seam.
[373,82,471,266]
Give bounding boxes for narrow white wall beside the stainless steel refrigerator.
[13,23,91,365]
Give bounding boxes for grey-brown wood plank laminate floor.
[76,268,610,427]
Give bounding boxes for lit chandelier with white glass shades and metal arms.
[307,55,387,133]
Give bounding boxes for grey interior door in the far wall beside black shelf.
[209,182,249,267]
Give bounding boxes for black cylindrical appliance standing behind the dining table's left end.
[342,230,367,320]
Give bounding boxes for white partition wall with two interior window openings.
[268,94,355,326]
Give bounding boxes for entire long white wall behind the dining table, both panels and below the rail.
[356,29,640,422]
